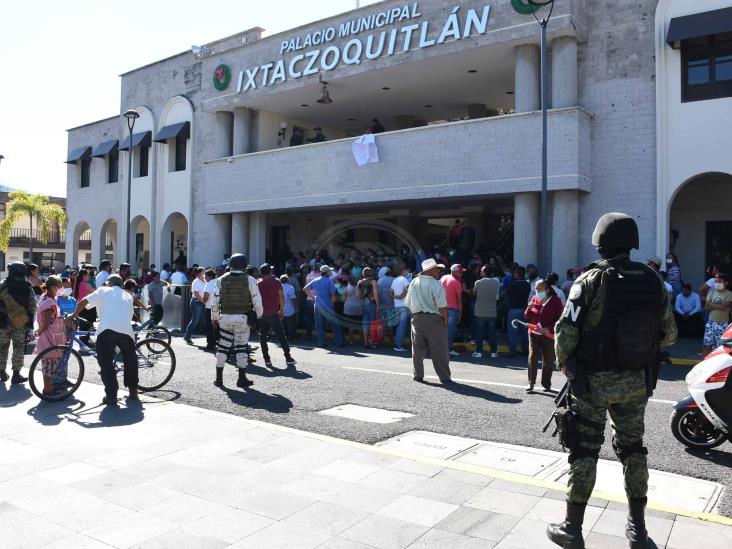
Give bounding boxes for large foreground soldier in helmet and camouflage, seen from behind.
[547,213,676,549]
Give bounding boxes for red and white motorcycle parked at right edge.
[671,324,732,449]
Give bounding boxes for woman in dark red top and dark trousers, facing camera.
[524,280,562,393]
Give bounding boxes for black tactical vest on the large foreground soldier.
[577,258,665,372]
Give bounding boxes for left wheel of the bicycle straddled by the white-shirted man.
[28,345,84,402]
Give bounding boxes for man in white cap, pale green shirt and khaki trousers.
[404,258,452,384]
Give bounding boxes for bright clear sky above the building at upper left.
[0,0,377,196]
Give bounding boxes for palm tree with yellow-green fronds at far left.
[0,191,66,263]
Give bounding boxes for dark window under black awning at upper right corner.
[681,32,732,102]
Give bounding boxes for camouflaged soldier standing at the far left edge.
[0,262,36,383]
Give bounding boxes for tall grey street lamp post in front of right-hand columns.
[511,0,556,275]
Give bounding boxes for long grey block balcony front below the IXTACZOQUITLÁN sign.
[203,109,590,213]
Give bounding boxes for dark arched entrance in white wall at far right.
[669,172,732,288]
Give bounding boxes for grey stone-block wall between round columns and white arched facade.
[578,0,657,264]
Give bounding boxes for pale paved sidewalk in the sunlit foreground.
[0,383,732,549]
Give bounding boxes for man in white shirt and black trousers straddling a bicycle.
[70,275,138,406]
